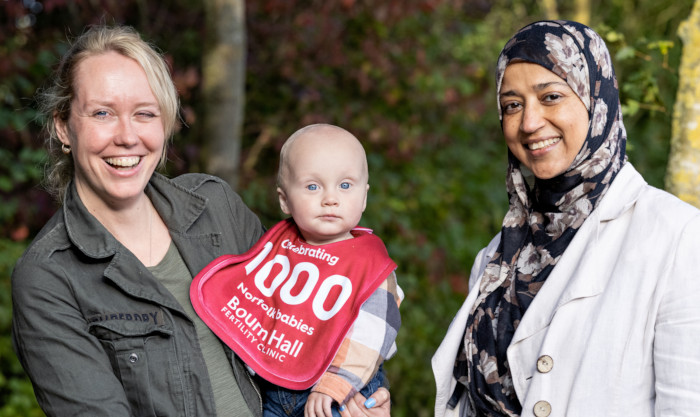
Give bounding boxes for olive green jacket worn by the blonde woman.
[12,174,263,417]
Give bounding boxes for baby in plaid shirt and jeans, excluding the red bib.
[263,124,403,417]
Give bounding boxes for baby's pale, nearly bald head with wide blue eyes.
[277,125,369,245]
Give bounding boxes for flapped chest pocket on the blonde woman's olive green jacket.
[89,320,185,417]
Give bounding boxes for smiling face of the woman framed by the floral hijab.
[499,62,588,179]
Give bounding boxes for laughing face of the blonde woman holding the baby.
[55,52,165,209]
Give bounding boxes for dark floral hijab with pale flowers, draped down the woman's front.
[450,20,627,416]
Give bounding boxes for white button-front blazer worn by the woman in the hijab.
[432,163,700,417]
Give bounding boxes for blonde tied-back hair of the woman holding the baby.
[38,25,179,203]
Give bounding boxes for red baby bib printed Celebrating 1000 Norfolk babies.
[190,219,396,390]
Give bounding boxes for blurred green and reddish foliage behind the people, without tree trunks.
[0,0,692,417]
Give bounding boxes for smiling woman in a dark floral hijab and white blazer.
[433,21,700,417]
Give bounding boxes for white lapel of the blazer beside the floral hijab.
[509,163,647,344]
